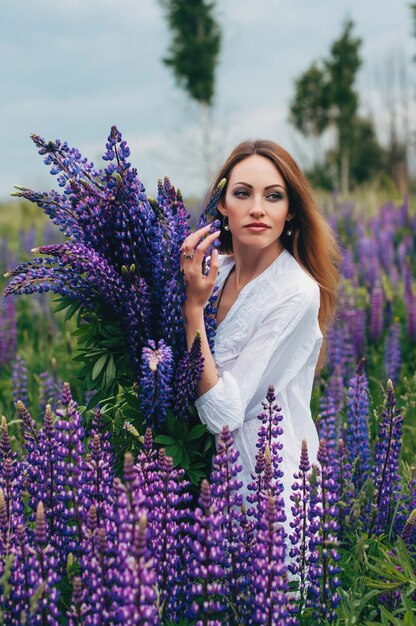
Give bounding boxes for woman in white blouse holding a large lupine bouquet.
[181,140,339,516]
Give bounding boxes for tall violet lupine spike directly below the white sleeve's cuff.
[211,426,249,621]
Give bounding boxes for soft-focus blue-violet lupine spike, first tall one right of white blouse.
[345,359,370,494]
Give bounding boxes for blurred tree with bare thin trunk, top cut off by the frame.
[161,0,221,180]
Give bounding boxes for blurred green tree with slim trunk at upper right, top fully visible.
[290,20,362,193]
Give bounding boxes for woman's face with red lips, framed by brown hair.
[218,154,292,251]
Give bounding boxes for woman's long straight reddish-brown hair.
[206,139,341,335]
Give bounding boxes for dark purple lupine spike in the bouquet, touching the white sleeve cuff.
[172,331,204,418]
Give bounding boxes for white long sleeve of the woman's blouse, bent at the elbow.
[195,277,321,433]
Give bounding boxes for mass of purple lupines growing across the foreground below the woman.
[0,363,416,626]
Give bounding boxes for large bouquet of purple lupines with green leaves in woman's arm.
[4,127,222,483]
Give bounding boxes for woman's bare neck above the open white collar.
[229,241,284,291]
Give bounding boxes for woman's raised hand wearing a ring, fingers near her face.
[180,225,220,316]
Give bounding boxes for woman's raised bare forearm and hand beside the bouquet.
[181,225,223,396]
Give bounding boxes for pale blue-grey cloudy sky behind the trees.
[0,0,416,201]
